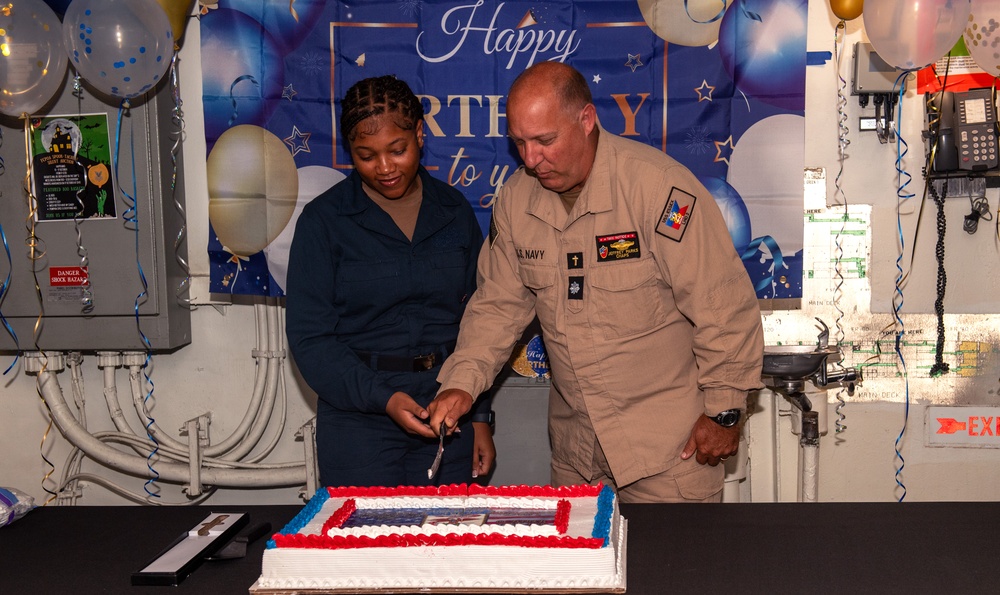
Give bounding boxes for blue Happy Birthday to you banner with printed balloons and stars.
[199,0,807,298]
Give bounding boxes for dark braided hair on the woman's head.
[340,74,424,142]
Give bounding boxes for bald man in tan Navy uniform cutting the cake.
[428,62,763,502]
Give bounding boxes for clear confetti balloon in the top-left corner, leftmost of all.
[0,0,66,118]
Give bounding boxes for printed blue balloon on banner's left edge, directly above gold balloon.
[201,8,285,150]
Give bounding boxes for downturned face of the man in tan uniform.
[507,90,596,192]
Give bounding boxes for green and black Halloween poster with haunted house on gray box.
[31,113,117,222]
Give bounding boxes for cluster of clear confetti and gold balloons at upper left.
[0,0,194,117]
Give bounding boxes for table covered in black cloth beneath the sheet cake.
[0,502,1000,595]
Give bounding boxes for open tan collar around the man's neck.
[527,125,615,231]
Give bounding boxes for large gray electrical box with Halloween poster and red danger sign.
[0,77,191,352]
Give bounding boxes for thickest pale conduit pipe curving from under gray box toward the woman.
[37,369,306,488]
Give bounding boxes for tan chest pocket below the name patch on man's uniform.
[589,258,667,339]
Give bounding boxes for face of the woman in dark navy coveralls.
[351,114,424,200]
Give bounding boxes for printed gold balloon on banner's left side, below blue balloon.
[207,124,299,256]
